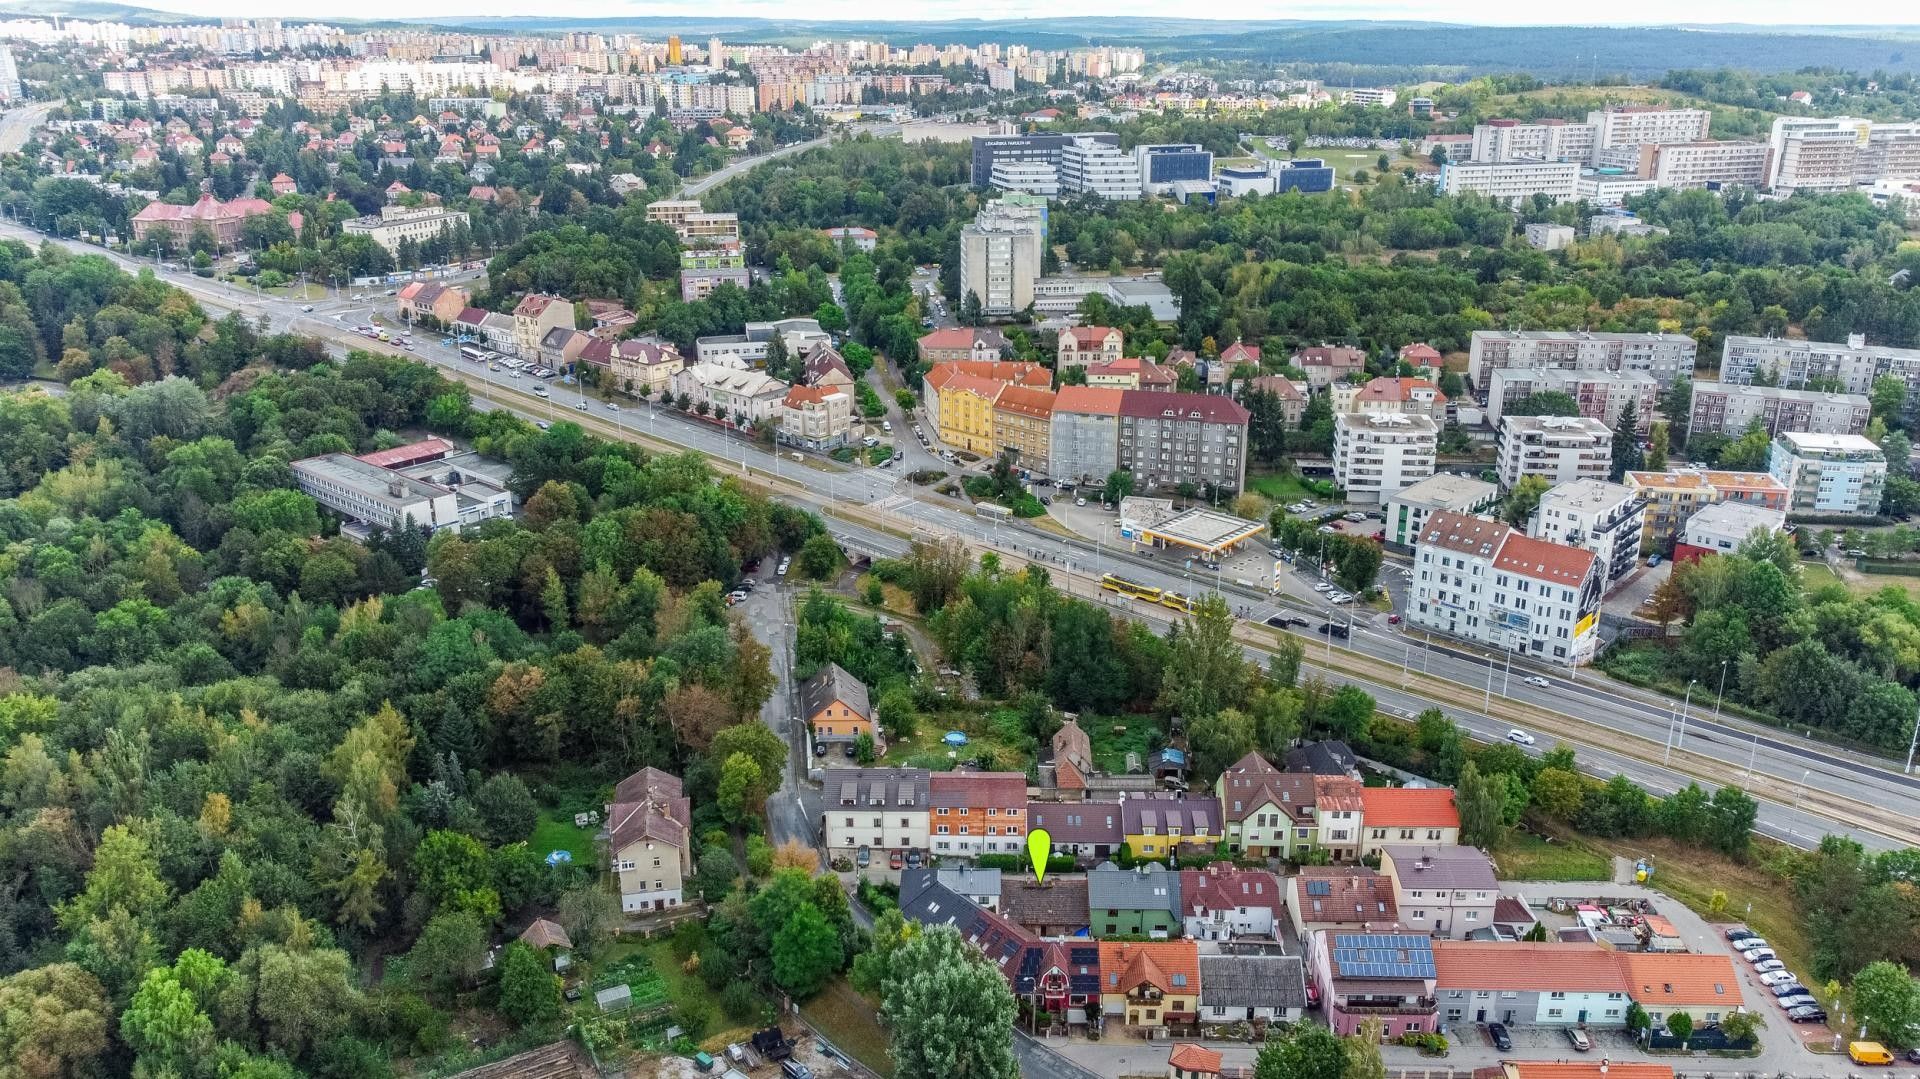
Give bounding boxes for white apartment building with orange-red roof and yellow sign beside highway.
[1407,511,1603,664]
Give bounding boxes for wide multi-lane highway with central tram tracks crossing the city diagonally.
[0,182,1920,849]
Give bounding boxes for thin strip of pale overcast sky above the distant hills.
[127,0,1920,27]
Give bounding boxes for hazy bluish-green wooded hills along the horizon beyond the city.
[6,0,1920,79]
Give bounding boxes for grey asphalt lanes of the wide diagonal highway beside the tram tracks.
[0,208,1920,849]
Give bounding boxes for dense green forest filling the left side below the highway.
[0,242,852,1079]
